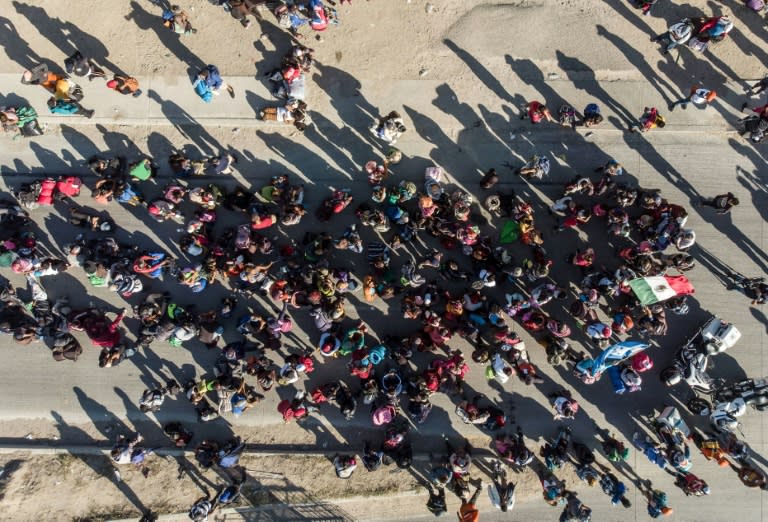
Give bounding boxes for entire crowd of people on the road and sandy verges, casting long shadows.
[0,0,768,521]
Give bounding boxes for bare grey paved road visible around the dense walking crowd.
[0,2,768,521]
